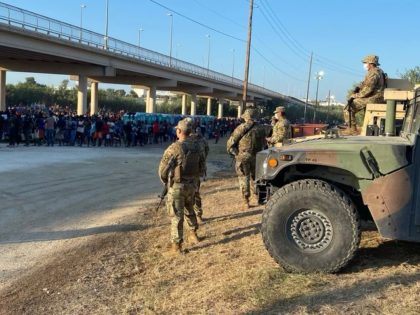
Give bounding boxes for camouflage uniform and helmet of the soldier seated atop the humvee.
[344,55,385,127]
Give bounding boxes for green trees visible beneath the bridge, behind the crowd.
[6,77,343,122]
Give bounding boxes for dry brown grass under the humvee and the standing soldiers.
[0,174,420,314]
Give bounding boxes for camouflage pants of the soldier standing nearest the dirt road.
[166,183,198,243]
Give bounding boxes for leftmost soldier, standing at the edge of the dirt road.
[159,119,205,254]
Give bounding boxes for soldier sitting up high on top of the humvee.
[344,55,386,134]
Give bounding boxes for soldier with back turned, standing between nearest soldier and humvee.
[227,108,266,209]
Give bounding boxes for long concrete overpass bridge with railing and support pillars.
[0,2,302,116]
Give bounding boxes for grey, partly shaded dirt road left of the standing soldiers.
[0,147,170,289]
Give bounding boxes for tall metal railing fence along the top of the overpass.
[0,2,284,97]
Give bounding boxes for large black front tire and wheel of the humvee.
[261,179,360,273]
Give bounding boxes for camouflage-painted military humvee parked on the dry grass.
[256,84,420,273]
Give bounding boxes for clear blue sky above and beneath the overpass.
[3,0,420,102]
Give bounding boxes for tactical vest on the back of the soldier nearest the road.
[174,140,203,183]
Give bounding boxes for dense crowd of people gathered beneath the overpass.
[0,106,240,147]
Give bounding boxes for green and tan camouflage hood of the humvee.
[257,136,412,178]
